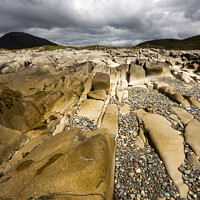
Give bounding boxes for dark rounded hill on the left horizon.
[0,32,57,49]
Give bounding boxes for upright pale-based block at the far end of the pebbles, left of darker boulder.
[129,63,145,85]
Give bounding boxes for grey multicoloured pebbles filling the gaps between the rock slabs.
[67,80,200,200]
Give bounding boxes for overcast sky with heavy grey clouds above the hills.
[0,0,200,46]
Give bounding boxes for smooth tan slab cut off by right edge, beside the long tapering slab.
[184,119,200,156]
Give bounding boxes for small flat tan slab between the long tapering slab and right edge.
[172,106,194,125]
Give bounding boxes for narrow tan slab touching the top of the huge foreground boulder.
[101,104,118,135]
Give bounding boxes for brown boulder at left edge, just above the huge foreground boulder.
[0,125,22,164]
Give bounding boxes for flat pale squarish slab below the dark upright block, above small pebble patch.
[78,99,104,124]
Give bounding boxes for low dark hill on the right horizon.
[136,35,200,50]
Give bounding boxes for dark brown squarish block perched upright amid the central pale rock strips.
[93,72,110,93]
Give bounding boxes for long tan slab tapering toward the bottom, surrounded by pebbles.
[136,109,188,198]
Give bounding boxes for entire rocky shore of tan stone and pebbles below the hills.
[0,48,200,200]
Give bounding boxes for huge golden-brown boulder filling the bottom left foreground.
[0,129,116,200]
